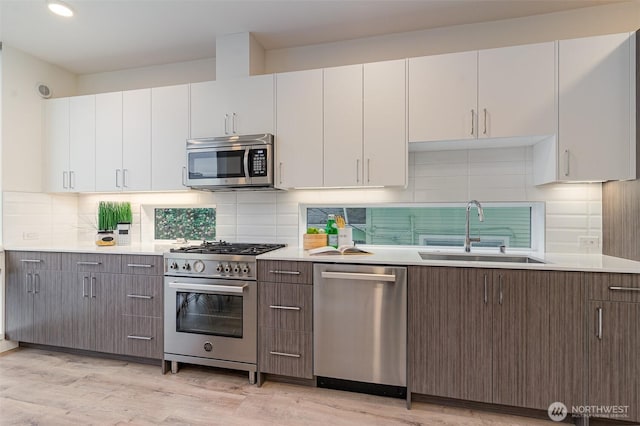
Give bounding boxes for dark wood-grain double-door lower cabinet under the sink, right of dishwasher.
[408,267,586,410]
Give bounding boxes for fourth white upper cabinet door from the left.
[122,89,151,191]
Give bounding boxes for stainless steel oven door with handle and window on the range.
[164,277,258,364]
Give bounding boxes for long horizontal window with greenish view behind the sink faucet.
[307,205,532,249]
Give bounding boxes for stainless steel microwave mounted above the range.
[187,133,274,191]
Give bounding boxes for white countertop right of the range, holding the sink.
[258,247,640,274]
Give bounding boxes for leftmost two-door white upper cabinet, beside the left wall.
[44,95,95,192]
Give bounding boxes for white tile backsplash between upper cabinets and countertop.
[3,147,602,253]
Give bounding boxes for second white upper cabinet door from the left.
[69,95,96,192]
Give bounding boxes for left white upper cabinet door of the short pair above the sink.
[408,51,478,142]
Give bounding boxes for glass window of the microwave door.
[189,150,245,179]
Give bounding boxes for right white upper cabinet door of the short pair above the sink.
[477,42,557,138]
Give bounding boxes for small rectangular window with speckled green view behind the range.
[154,208,216,241]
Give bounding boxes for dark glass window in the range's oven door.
[176,292,242,338]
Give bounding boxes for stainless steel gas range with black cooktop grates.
[163,241,284,384]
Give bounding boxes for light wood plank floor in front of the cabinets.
[0,348,554,426]
